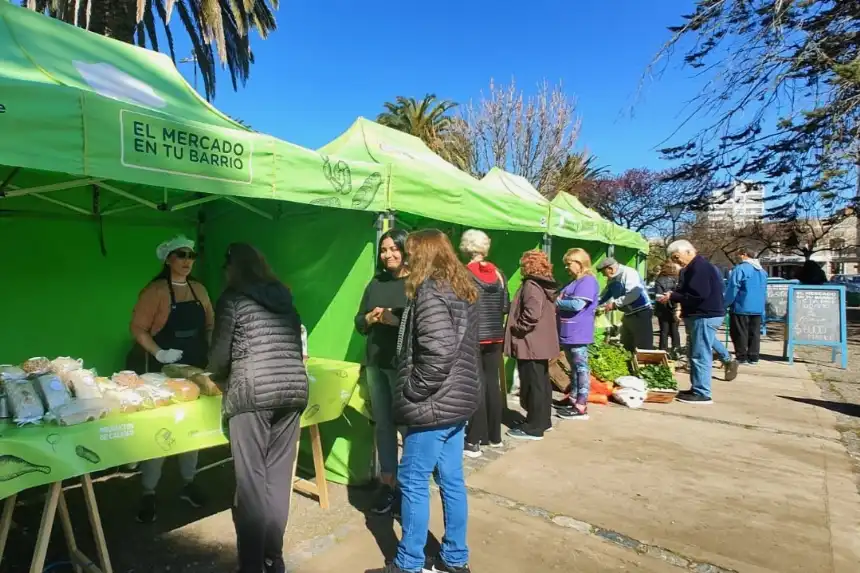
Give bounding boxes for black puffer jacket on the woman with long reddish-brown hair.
[394,280,480,428]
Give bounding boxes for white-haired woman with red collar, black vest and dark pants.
[460,229,510,458]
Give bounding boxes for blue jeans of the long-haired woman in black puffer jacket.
[394,423,469,573]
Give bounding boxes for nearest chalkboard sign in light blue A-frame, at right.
[786,284,848,368]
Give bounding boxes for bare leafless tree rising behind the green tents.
[452,80,580,196]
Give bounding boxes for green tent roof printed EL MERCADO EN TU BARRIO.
[0,2,385,210]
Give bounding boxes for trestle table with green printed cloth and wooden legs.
[0,358,365,573]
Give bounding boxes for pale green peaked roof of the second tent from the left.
[320,117,547,233]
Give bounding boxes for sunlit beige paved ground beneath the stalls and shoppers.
[0,336,860,573]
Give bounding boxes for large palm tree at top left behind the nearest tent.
[22,0,278,100]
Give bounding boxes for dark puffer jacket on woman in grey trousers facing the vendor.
[209,283,308,418]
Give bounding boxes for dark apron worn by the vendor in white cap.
[127,279,209,374]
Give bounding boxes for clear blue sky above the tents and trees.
[179,0,698,171]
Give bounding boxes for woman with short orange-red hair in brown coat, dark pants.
[505,251,560,440]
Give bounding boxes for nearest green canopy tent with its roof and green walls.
[0,2,387,480]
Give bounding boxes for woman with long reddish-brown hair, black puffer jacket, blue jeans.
[372,230,481,573]
